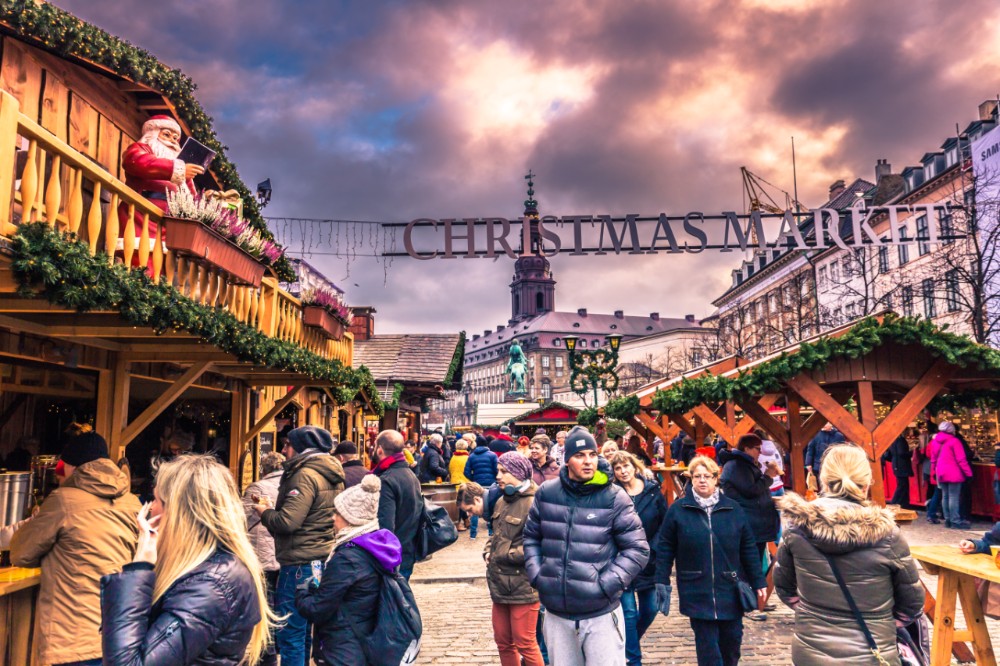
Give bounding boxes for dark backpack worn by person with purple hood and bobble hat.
[345,548,423,666]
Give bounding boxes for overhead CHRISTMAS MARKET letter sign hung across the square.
[398,203,964,260]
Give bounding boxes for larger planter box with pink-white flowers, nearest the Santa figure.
[163,187,283,287]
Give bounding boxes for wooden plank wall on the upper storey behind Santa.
[0,36,147,180]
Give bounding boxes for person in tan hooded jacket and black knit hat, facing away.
[10,424,141,666]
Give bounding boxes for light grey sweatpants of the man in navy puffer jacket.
[542,606,625,666]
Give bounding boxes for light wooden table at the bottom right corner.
[910,546,1000,666]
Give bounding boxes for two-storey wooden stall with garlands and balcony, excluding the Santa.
[0,7,381,664]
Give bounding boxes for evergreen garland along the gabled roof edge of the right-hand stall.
[652,314,1000,414]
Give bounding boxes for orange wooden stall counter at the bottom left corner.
[0,567,42,666]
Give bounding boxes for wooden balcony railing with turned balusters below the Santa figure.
[0,90,354,365]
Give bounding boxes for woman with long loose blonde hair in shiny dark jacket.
[101,455,275,666]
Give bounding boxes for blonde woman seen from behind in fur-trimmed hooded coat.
[774,445,924,666]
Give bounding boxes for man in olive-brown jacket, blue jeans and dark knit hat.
[254,426,344,666]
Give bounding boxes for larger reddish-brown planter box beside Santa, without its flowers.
[163,217,264,287]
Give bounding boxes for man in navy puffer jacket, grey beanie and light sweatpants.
[524,426,649,666]
